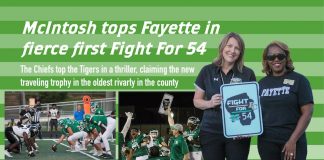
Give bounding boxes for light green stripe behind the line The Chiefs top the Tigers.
[0,61,324,76]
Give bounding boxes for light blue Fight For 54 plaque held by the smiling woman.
[221,82,263,138]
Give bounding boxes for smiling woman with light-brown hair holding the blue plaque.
[193,32,256,160]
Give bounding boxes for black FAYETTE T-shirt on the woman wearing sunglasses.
[259,71,314,143]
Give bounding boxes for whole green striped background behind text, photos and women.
[0,0,324,160]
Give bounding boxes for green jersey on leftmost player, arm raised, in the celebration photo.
[127,134,148,159]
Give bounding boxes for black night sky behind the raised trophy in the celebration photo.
[119,92,202,124]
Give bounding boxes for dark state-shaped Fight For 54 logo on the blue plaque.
[225,93,255,125]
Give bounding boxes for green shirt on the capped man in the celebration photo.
[170,135,189,160]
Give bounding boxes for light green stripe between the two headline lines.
[0,34,324,48]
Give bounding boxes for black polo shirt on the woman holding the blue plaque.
[195,64,256,134]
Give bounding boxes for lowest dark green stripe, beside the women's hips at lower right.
[251,132,324,145]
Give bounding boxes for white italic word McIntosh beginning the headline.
[23,21,97,34]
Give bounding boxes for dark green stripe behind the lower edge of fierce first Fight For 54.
[0,48,324,63]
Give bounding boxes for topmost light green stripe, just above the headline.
[0,7,324,21]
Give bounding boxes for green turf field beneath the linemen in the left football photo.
[6,139,115,160]
